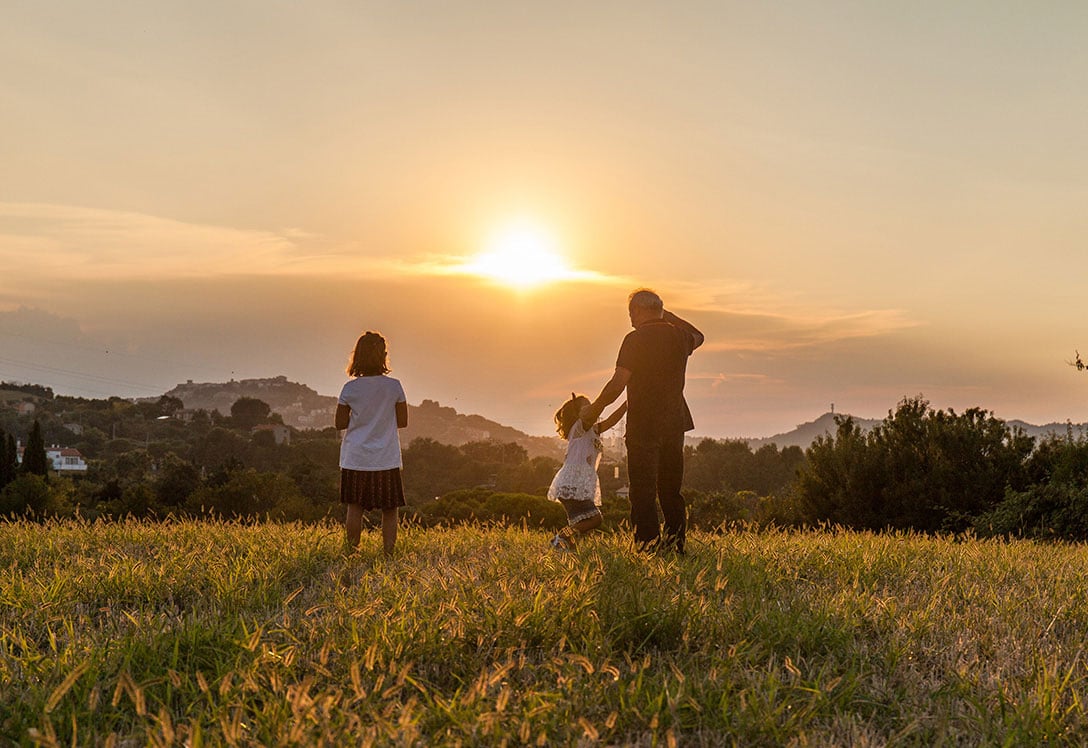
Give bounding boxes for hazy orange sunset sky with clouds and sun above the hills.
[0,0,1088,437]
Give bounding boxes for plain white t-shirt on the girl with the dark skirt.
[337,374,407,471]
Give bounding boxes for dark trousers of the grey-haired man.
[627,432,688,551]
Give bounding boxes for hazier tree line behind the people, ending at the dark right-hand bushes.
[0,396,803,523]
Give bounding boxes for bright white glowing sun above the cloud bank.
[463,220,578,289]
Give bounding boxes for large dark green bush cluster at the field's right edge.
[790,397,1088,540]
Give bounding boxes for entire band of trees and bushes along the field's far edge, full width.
[6,389,1088,540]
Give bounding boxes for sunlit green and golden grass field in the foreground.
[0,522,1088,746]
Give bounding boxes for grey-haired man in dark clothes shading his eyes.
[582,288,703,553]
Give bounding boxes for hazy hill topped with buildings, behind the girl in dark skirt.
[166,376,564,460]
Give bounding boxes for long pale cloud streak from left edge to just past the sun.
[0,202,627,293]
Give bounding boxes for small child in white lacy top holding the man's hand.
[547,392,627,550]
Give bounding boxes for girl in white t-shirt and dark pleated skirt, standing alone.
[336,333,408,556]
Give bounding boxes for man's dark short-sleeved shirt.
[616,320,695,439]
